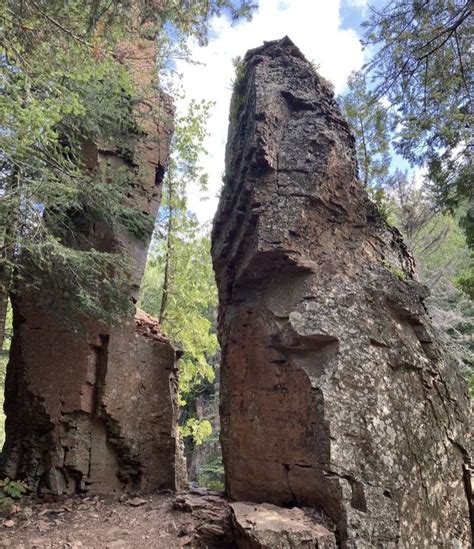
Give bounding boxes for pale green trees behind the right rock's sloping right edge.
[389,171,474,390]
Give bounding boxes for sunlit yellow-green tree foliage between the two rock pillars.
[139,218,218,443]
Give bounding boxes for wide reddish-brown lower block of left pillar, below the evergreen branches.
[3,299,185,494]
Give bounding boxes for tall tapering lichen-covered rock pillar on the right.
[212,38,470,547]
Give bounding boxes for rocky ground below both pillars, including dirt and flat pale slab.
[0,489,336,549]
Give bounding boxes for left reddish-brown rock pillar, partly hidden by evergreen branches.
[2,22,185,494]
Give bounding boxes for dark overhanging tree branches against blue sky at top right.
[364,0,474,240]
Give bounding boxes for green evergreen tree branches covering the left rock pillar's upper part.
[0,0,252,346]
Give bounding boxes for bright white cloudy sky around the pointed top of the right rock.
[169,0,367,223]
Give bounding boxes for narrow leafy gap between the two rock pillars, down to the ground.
[138,211,224,491]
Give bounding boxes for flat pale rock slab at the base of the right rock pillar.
[230,503,336,549]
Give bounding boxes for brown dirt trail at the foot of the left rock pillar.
[0,493,213,549]
